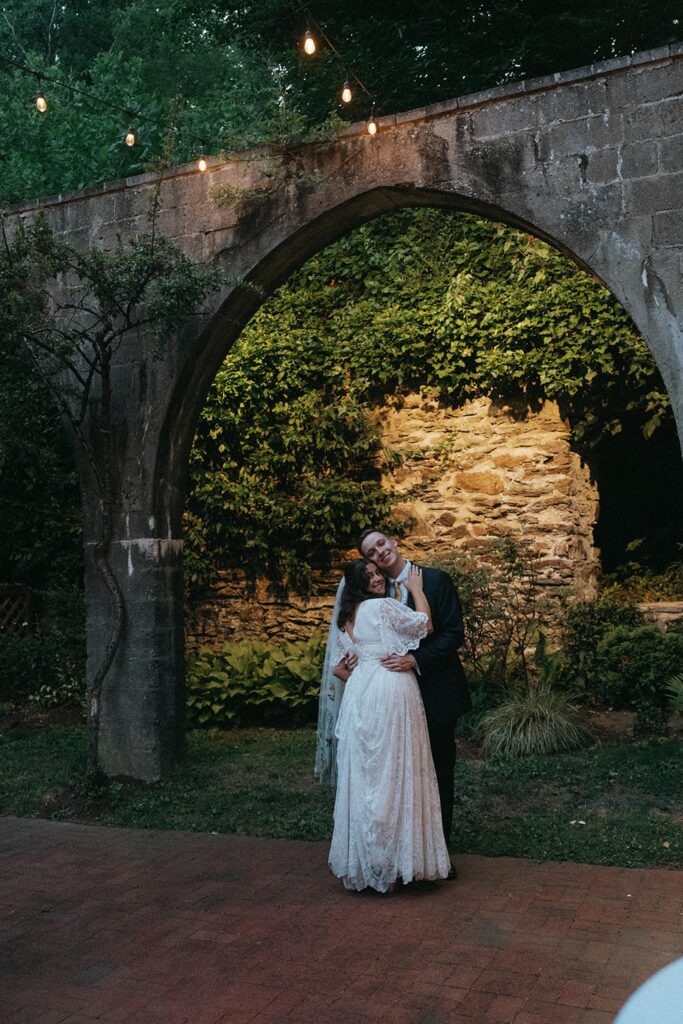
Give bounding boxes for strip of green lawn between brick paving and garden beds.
[0,725,683,867]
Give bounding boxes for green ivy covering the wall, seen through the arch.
[186,210,671,590]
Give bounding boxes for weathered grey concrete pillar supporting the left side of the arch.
[79,348,186,781]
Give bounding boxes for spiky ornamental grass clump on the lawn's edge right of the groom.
[479,683,591,758]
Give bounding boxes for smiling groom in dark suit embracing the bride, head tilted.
[358,528,471,843]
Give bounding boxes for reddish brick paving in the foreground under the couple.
[0,818,683,1024]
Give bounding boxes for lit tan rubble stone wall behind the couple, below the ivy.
[186,394,600,648]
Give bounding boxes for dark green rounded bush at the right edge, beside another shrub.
[593,626,683,732]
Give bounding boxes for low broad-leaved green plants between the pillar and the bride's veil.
[187,637,325,726]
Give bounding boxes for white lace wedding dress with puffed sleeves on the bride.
[329,597,451,892]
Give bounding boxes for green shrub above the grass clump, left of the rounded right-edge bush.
[561,597,643,699]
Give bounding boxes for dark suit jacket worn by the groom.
[408,568,472,723]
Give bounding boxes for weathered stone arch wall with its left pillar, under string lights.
[12,37,683,779]
